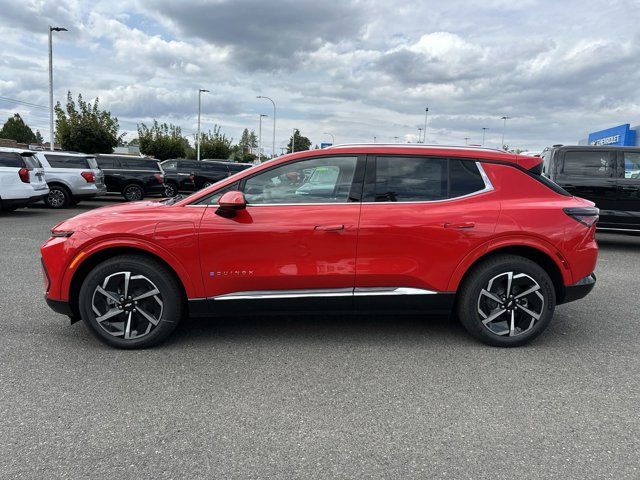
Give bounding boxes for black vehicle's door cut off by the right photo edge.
[616,151,640,230]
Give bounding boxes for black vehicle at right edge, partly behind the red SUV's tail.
[542,145,640,233]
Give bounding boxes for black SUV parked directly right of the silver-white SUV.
[96,154,164,202]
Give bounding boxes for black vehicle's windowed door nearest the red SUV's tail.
[556,148,618,227]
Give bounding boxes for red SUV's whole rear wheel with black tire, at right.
[457,255,556,347]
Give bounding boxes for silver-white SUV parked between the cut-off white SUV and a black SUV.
[36,150,107,208]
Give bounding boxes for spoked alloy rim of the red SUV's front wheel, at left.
[91,271,164,340]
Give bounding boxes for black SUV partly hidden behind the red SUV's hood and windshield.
[161,158,252,197]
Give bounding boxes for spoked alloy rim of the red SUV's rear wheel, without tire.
[477,272,545,337]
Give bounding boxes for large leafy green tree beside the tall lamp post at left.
[55,92,123,153]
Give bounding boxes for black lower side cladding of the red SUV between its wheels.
[189,292,455,317]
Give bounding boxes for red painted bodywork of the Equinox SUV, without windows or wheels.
[41,145,597,314]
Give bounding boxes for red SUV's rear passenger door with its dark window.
[355,156,499,310]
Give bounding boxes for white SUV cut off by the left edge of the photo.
[0,147,49,211]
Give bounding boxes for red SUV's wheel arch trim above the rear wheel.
[449,244,572,303]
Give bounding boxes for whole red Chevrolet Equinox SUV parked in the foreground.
[41,144,598,348]
